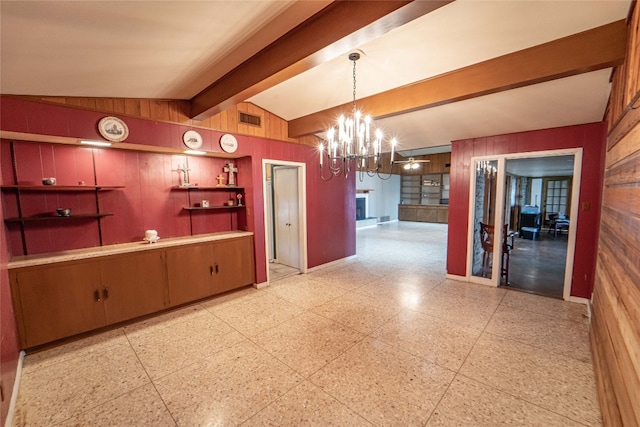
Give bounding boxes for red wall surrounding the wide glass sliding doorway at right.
[447,122,607,298]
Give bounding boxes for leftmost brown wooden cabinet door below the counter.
[15,262,105,347]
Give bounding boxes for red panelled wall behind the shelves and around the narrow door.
[0,97,356,408]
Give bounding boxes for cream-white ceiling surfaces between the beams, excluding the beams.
[0,0,630,153]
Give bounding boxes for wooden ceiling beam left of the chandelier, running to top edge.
[190,0,453,120]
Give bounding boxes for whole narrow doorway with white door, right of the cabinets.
[263,159,307,282]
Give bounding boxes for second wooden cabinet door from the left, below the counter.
[100,250,168,324]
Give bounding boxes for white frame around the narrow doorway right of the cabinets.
[262,159,308,283]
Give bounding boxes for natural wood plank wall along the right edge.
[591,3,640,426]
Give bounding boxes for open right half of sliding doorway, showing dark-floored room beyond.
[501,155,575,298]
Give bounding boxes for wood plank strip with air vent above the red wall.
[15,96,300,144]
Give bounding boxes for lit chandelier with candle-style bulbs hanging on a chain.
[318,52,398,181]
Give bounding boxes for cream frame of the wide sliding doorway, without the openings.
[466,147,582,301]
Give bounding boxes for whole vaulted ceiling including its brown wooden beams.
[0,0,631,154]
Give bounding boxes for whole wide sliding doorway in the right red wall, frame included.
[467,149,582,300]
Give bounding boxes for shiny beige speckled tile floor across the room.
[14,223,601,426]
